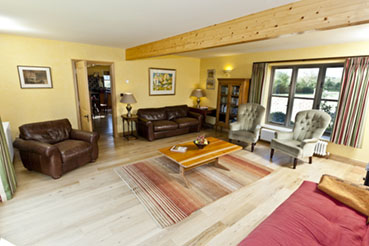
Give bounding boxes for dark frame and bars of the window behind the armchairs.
[265,62,344,135]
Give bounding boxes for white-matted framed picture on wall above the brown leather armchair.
[18,66,53,88]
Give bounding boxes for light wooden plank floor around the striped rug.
[0,131,364,246]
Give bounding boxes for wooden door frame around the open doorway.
[72,59,118,138]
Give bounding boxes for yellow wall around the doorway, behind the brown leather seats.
[0,35,200,138]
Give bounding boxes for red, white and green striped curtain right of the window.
[332,57,369,148]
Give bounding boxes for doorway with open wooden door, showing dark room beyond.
[73,61,117,137]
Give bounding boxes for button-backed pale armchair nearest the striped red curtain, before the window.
[270,109,331,169]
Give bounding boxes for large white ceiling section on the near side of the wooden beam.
[0,0,296,48]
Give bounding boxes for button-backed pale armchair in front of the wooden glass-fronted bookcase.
[228,103,265,152]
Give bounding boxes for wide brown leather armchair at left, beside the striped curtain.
[14,119,99,179]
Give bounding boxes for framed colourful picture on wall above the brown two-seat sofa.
[149,68,176,96]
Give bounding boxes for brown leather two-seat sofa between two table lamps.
[137,105,202,141]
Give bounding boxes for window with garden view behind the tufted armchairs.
[267,64,343,136]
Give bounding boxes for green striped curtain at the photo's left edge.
[0,118,17,202]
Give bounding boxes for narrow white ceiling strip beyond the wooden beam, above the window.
[181,24,369,58]
